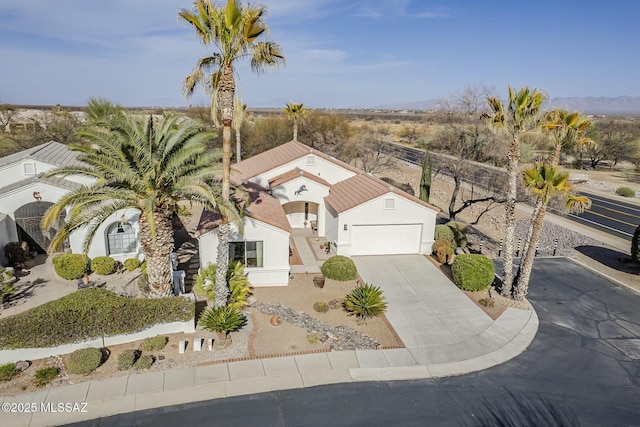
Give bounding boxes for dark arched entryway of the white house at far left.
[14,201,64,254]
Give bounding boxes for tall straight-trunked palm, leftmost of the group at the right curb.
[485,86,547,296]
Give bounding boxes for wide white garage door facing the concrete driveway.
[351,224,422,255]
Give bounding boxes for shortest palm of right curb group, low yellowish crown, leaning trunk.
[513,163,591,300]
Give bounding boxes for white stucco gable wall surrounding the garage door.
[327,192,436,256]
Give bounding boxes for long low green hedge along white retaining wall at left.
[0,288,195,349]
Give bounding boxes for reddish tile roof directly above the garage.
[324,172,440,214]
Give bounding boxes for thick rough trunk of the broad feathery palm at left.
[139,212,174,297]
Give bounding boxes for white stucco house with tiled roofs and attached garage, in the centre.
[197,141,438,286]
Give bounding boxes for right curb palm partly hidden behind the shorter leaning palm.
[520,109,591,262]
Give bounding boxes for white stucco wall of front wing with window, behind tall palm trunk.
[198,217,289,286]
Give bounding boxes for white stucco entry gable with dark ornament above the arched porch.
[272,175,329,236]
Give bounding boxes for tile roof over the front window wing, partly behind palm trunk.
[196,183,291,236]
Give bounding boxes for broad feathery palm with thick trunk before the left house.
[42,114,238,296]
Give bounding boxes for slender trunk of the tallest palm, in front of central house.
[214,66,235,307]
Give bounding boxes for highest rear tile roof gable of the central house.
[235,141,362,179]
